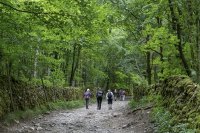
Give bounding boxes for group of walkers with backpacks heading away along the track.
[84,88,125,110]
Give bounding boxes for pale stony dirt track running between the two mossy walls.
[3,101,153,133]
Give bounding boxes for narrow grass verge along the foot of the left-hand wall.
[3,100,84,125]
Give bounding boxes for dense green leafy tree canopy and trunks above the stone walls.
[0,0,200,88]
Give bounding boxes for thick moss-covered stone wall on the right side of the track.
[151,75,200,129]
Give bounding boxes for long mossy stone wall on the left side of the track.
[0,76,83,118]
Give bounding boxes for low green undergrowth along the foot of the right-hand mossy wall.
[129,95,197,133]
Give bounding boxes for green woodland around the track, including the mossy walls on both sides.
[0,0,200,133]
